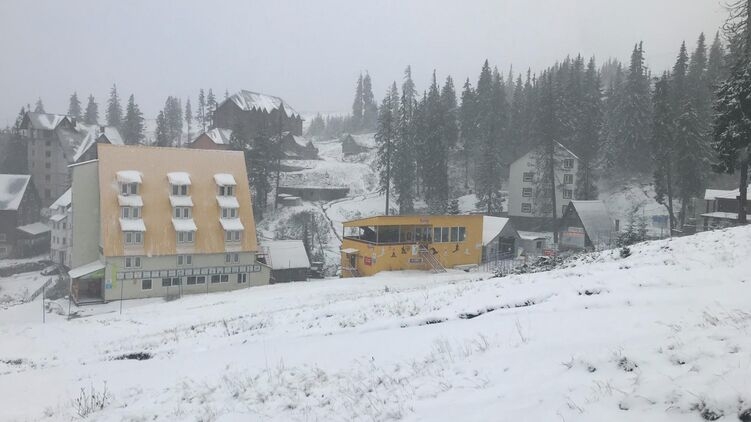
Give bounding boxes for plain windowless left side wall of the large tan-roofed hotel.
[68,161,100,268]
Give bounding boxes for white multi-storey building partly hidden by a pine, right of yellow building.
[508,142,579,226]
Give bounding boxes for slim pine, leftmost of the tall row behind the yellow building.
[375,82,399,215]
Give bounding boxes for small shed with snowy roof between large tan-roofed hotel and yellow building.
[263,240,310,283]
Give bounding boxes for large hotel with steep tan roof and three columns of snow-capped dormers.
[69,144,269,302]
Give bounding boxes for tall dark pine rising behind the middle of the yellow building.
[419,71,449,214]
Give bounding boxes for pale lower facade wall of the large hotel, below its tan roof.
[102,252,270,301]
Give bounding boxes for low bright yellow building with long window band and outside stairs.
[341,215,520,277]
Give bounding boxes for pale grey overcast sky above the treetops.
[0,0,726,126]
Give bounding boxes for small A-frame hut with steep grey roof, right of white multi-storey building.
[558,200,615,250]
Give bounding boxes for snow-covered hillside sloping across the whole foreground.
[0,227,751,422]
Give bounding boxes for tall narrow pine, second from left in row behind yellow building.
[392,66,417,214]
